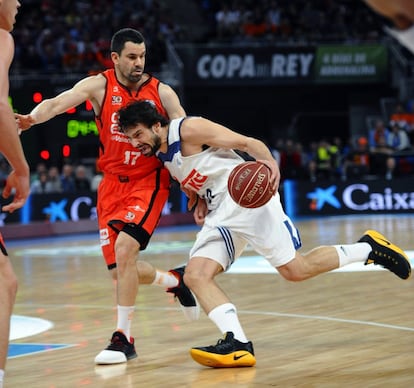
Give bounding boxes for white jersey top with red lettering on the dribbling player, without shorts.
[157,118,244,210]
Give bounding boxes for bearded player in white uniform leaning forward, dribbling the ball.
[119,101,411,367]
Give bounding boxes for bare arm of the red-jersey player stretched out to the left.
[16,75,106,130]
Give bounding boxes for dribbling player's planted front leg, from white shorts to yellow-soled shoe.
[184,229,256,367]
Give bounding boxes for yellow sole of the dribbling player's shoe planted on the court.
[190,349,256,368]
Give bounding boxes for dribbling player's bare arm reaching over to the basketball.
[181,117,280,192]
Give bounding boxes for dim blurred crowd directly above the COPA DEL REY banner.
[199,0,383,44]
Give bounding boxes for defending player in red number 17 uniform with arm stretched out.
[16,28,199,364]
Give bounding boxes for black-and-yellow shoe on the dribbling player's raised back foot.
[359,230,411,280]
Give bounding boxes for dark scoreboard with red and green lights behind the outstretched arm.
[10,77,99,168]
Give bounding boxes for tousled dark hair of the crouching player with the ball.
[118,100,169,132]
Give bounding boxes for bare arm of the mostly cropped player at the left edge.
[0,29,30,212]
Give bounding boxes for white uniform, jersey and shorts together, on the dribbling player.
[157,118,301,270]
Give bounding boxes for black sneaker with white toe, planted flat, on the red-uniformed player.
[95,331,137,364]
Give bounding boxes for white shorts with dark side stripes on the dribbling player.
[190,194,302,271]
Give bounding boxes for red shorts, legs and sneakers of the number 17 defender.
[95,178,198,364]
